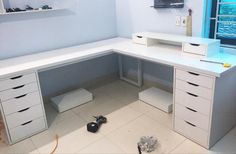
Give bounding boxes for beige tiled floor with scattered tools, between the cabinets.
[0,81,236,154]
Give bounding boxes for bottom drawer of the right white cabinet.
[175,117,208,148]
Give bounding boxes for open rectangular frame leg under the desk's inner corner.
[118,55,143,87]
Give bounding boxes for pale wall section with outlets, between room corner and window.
[116,0,204,37]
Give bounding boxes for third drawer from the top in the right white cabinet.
[175,89,211,115]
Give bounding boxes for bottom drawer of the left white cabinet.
[10,117,46,142]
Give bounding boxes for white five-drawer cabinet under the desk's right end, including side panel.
[173,67,236,149]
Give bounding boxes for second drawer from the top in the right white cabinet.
[176,79,212,100]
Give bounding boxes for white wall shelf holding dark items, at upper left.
[0,0,64,15]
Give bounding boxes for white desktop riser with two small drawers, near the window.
[133,32,220,57]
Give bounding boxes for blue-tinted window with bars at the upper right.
[209,0,236,47]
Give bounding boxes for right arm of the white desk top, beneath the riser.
[113,41,236,77]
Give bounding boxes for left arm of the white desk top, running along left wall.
[0,38,126,78]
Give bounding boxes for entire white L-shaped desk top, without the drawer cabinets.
[0,38,236,78]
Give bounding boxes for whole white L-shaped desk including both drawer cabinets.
[0,35,236,148]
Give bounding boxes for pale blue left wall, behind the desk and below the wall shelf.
[0,0,116,59]
